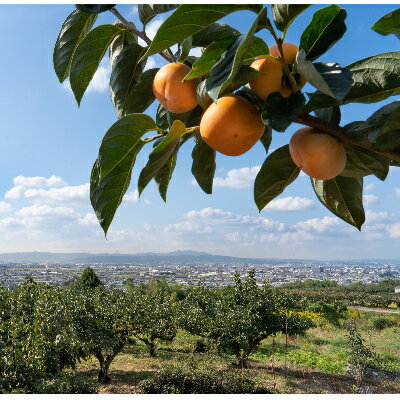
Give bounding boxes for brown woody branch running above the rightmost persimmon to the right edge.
[295,113,400,162]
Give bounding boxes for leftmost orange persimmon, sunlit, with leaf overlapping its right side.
[153,63,199,114]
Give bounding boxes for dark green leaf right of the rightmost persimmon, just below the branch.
[340,144,389,181]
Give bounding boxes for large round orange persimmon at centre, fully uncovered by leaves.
[200,96,264,156]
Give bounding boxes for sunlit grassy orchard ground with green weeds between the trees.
[68,310,400,393]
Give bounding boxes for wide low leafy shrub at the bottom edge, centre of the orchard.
[140,361,268,394]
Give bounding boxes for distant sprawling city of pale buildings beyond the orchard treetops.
[0,252,400,288]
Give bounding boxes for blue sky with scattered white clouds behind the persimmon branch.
[0,5,400,259]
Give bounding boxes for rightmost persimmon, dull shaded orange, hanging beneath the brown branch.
[289,127,347,180]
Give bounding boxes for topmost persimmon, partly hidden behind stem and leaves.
[250,43,306,100]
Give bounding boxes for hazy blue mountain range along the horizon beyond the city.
[0,250,399,265]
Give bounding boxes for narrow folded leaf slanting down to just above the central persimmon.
[206,8,267,100]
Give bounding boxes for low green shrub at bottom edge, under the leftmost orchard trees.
[33,374,98,394]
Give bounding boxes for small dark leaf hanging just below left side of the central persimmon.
[192,134,216,194]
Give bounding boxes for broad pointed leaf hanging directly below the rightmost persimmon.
[311,176,365,230]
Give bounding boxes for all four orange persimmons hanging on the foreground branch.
[153,43,346,179]
